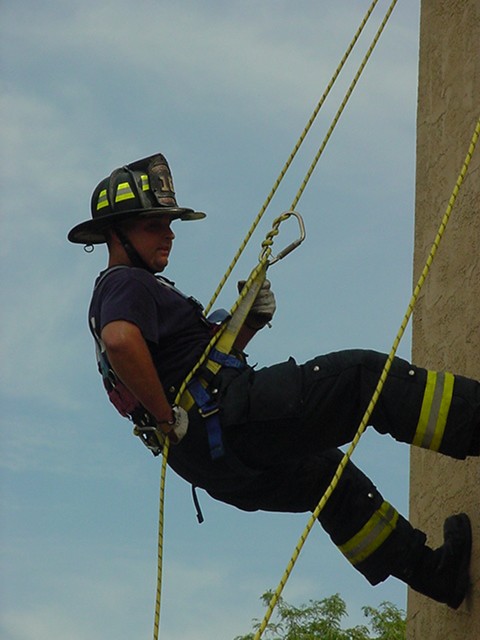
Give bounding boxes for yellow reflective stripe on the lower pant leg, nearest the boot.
[338,502,398,565]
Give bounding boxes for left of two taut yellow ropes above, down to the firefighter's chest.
[205,0,378,313]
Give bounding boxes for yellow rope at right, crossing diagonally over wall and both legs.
[254,118,480,640]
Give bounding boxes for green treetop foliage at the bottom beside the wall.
[235,591,406,640]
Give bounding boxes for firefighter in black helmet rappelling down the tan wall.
[68,154,480,609]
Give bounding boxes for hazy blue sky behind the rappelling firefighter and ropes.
[0,0,419,640]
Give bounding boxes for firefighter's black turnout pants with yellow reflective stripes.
[170,350,480,584]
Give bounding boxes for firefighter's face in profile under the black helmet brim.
[127,215,175,272]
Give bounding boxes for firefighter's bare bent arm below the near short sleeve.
[101,320,173,433]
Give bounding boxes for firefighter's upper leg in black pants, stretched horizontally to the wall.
[221,350,480,469]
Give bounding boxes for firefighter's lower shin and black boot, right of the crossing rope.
[319,451,472,609]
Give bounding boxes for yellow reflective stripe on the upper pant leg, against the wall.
[413,371,455,451]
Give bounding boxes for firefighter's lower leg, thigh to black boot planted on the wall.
[214,449,471,608]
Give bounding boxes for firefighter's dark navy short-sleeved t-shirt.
[89,267,211,398]
